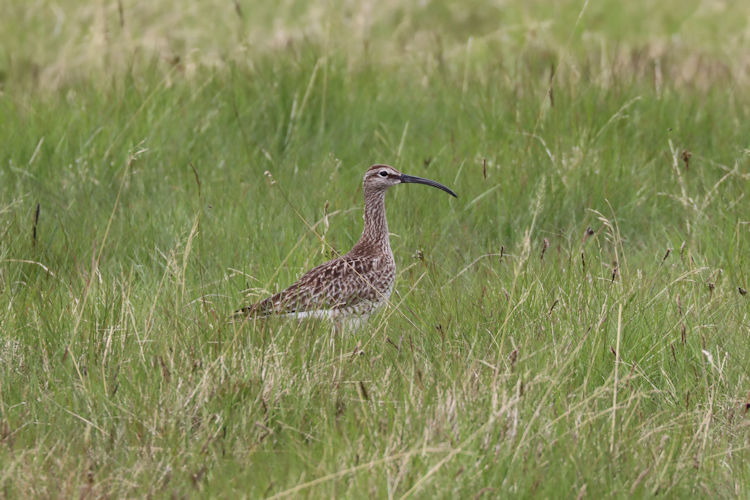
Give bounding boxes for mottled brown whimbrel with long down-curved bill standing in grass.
[236,165,457,328]
